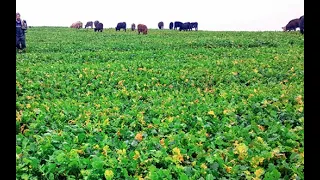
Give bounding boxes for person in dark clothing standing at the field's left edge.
[16,13,27,52]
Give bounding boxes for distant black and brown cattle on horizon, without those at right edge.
[70,21,198,34]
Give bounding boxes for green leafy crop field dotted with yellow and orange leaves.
[16,27,304,180]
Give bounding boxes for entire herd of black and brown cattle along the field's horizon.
[70,15,304,34]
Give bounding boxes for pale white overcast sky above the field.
[16,0,304,31]
